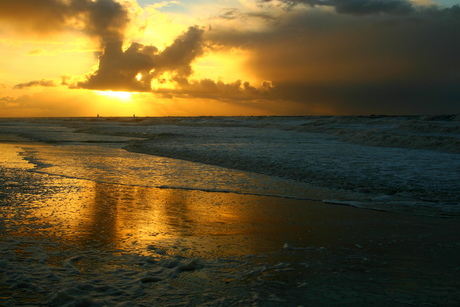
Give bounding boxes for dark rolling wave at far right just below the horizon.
[295,116,460,153]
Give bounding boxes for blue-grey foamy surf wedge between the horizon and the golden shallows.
[111,117,460,215]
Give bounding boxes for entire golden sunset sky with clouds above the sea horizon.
[0,0,460,117]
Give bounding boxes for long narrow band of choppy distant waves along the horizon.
[61,115,460,153]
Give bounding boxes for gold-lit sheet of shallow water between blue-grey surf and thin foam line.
[17,145,342,200]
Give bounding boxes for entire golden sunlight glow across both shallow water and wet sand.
[2,144,318,256]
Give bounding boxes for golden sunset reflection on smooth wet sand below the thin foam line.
[22,172,288,255]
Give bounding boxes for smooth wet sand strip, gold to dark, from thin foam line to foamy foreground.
[0,153,460,303]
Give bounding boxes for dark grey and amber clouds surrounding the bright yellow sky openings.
[0,0,460,114]
